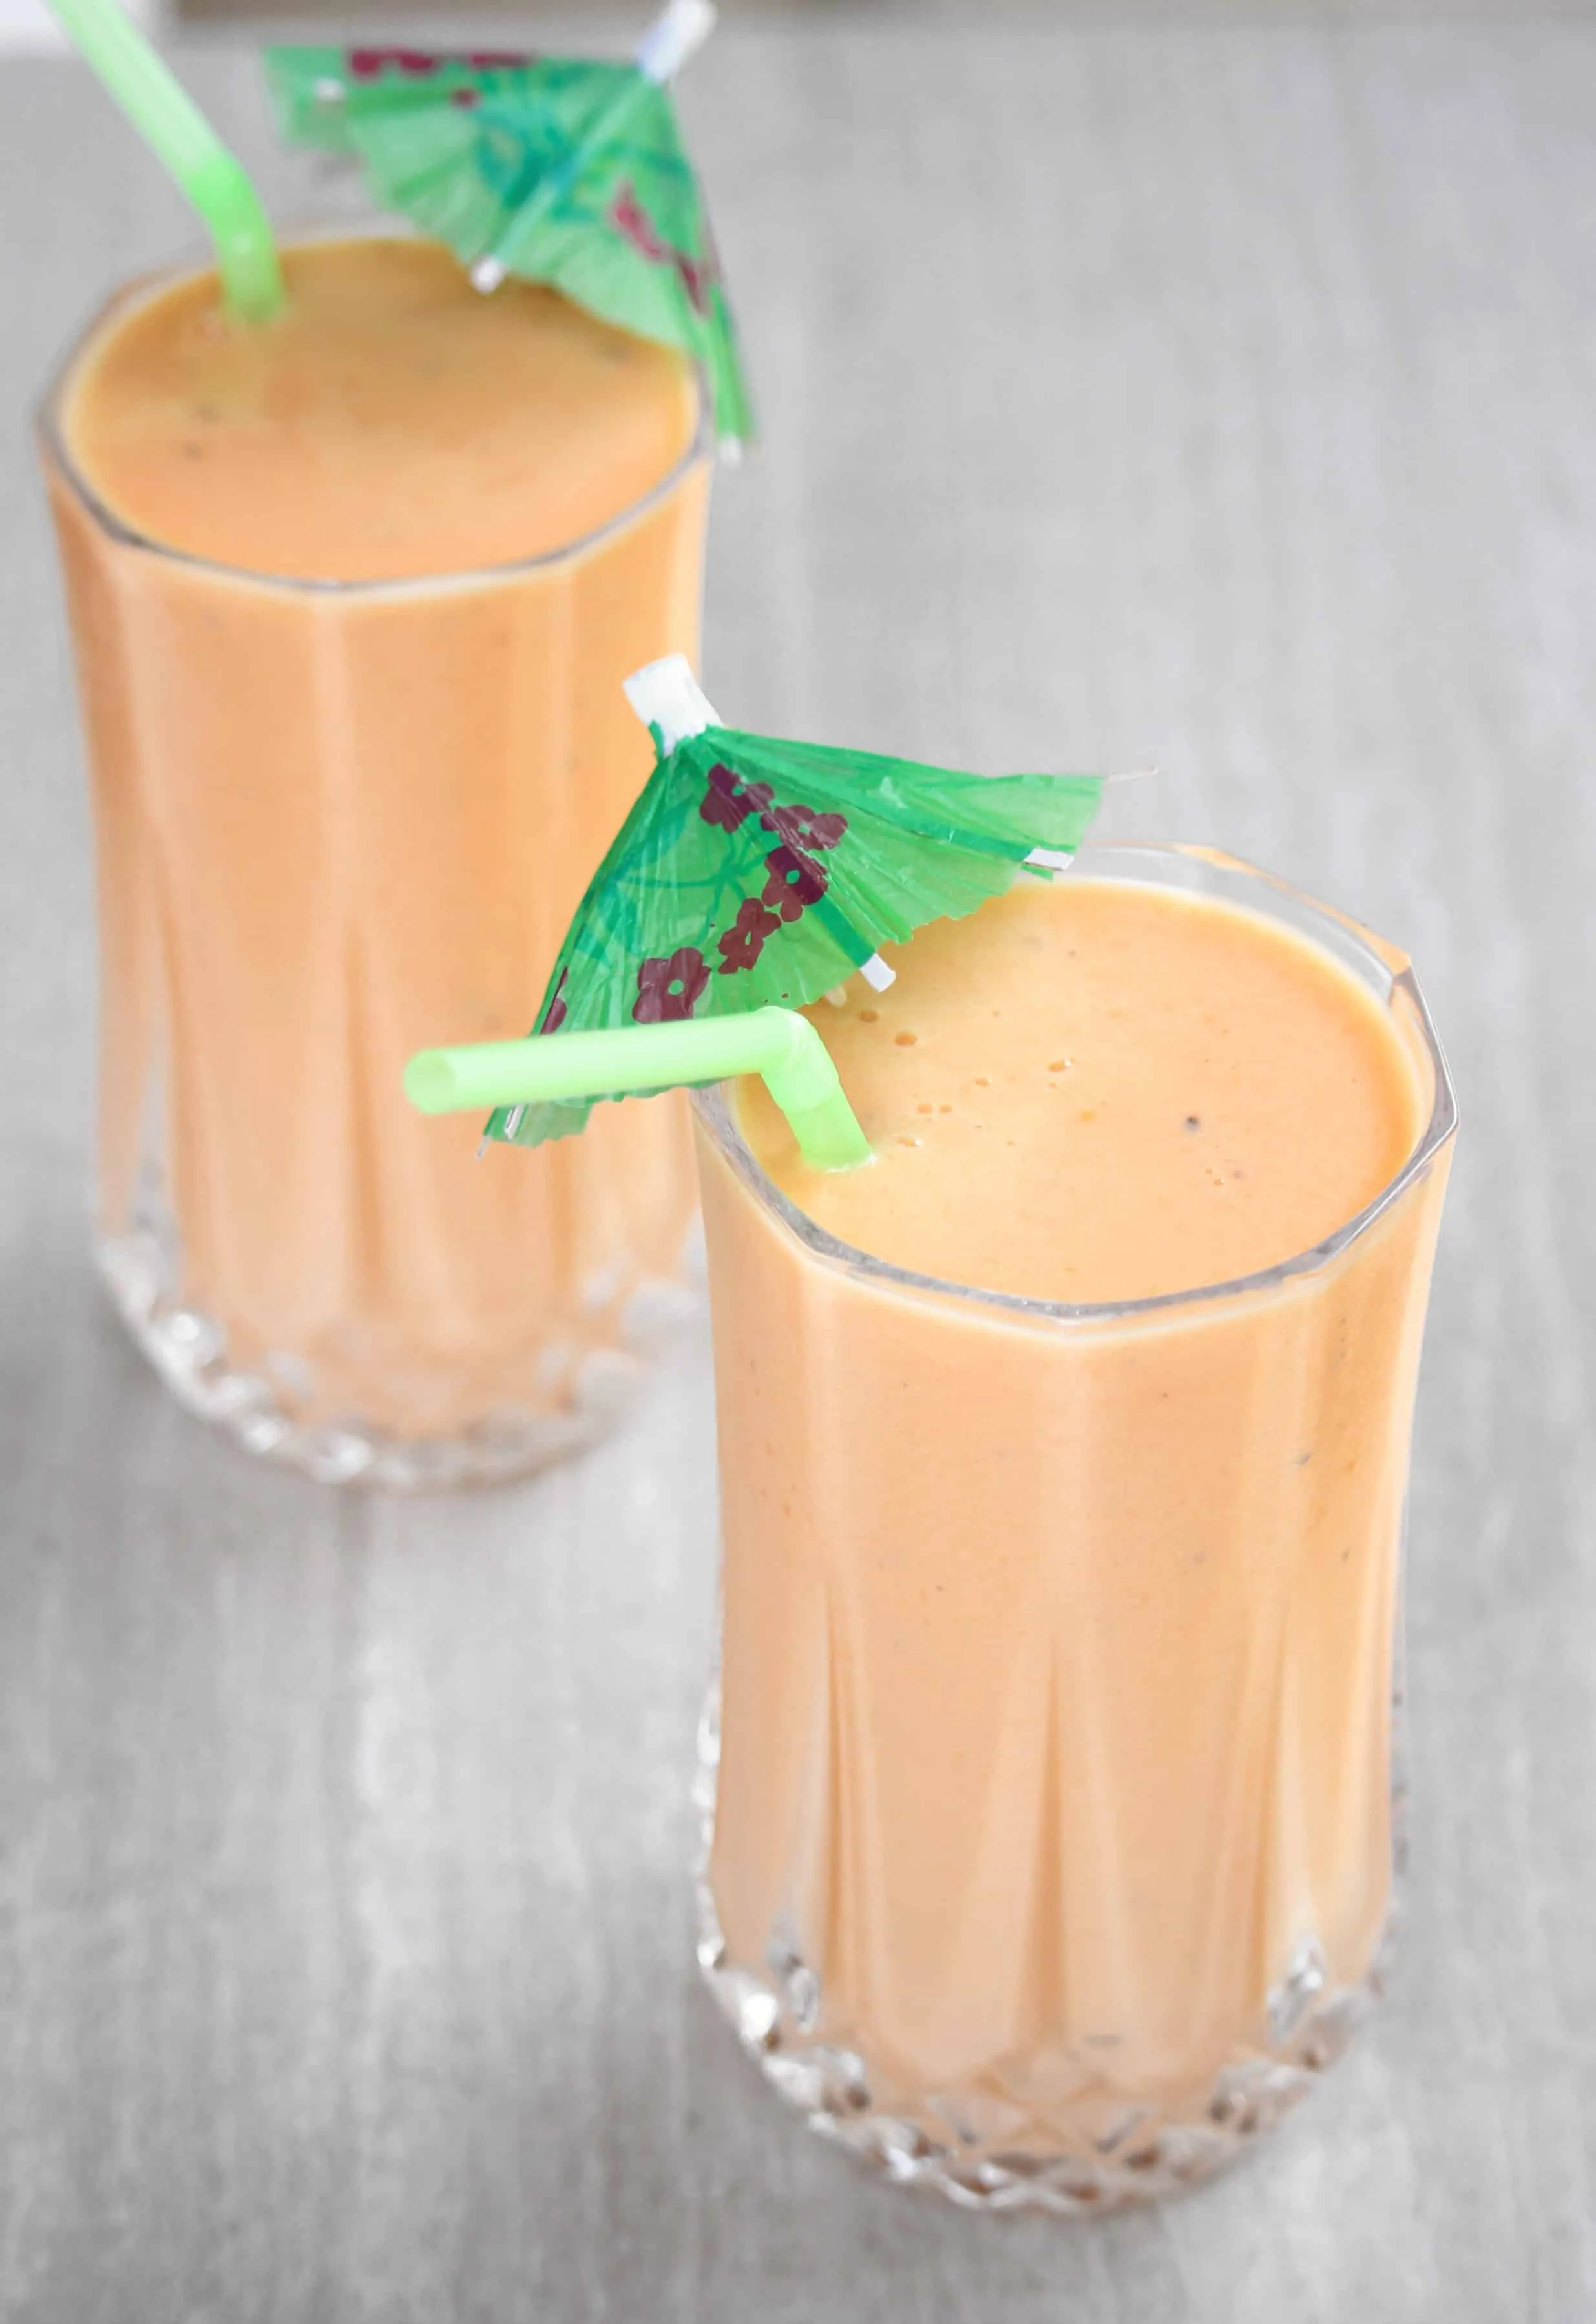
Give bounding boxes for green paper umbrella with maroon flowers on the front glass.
[488,653,1104,1146]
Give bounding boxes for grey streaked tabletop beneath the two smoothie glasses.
[0,14,1596,2324]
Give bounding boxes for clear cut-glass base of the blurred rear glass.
[95,1227,697,1492]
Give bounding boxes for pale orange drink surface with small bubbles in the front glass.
[744,876,1420,1304]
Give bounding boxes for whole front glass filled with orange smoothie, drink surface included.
[702,849,1449,2208]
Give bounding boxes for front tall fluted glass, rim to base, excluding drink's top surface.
[697,849,1454,2212]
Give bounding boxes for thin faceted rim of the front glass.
[692,839,1456,1329]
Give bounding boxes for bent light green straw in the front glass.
[404,1009,871,1169]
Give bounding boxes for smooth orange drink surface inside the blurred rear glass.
[65,237,695,581]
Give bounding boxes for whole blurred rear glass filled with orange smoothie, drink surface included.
[44,237,709,1483]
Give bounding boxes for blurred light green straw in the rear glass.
[49,0,284,323]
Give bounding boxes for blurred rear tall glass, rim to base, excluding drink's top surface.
[42,249,711,1485]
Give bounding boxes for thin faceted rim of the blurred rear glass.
[32,218,715,604]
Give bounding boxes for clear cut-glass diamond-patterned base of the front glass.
[695,1692,1389,2217]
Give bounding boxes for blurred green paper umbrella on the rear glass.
[267,0,753,441]
